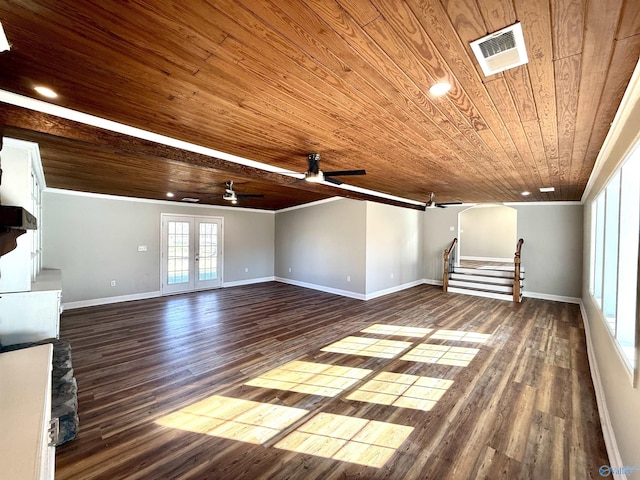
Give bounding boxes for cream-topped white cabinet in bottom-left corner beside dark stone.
[0,344,55,480]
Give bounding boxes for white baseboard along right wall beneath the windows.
[580,299,627,480]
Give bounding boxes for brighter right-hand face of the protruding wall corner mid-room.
[366,202,424,296]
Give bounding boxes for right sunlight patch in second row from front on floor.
[347,372,453,412]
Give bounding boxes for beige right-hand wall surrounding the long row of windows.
[582,68,640,478]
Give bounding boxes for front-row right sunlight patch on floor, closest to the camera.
[275,413,413,468]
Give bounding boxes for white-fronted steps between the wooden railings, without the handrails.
[448,267,524,301]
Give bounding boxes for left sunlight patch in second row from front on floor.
[245,361,371,397]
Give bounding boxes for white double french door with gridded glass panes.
[160,213,222,295]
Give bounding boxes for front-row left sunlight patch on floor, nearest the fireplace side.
[156,395,308,444]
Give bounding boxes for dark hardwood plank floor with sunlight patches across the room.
[56,283,608,480]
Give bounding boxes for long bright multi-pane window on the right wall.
[589,146,640,370]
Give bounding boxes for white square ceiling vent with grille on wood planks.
[471,22,529,77]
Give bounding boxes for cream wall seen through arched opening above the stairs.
[459,205,518,261]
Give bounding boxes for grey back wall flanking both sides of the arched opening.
[424,204,582,300]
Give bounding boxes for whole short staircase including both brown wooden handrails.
[442,238,524,303]
